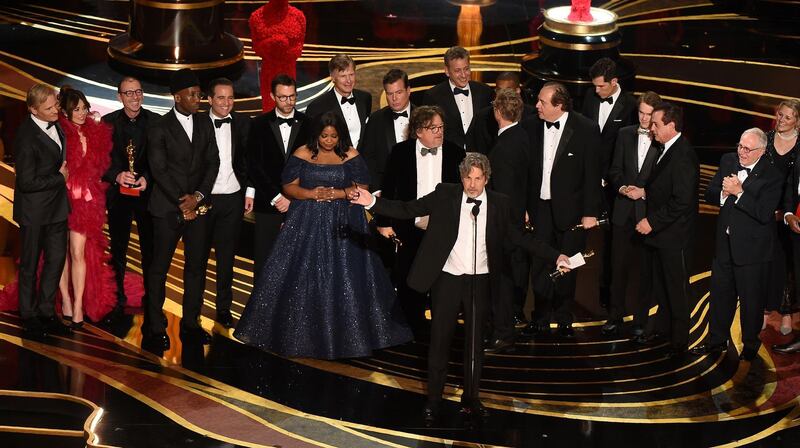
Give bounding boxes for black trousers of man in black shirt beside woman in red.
[108,194,153,307]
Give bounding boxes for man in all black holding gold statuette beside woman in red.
[103,76,159,320]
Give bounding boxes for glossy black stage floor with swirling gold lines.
[0,0,800,448]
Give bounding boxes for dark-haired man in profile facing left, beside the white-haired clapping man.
[636,102,700,357]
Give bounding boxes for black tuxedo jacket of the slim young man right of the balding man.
[608,124,658,226]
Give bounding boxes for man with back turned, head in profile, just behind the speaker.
[486,89,530,352]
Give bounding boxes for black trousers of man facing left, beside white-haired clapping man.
[644,245,689,350]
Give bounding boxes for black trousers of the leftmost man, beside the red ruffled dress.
[19,221,67,320]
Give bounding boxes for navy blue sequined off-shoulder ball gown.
[234,156,412,359]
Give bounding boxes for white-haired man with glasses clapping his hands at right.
[691,128,783,361]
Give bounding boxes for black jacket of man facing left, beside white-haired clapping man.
[644,136,700,249]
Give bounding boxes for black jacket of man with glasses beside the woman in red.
[103,108,161,207]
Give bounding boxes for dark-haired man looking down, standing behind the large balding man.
[581,58,637,307]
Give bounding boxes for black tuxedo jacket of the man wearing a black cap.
[147,109,219,218]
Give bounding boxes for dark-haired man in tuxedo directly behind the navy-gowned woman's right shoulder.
[358,68,415,190]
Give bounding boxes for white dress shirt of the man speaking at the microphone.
[442,190,489,275]
